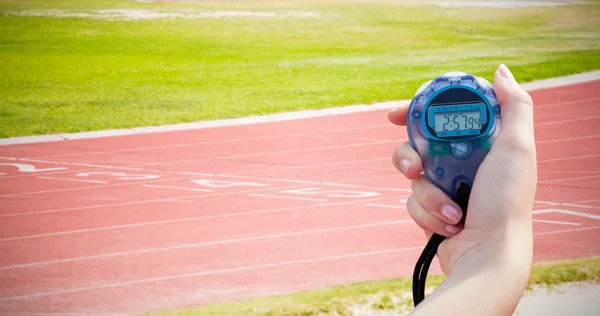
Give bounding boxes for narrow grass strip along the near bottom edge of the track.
[148,257,600,316]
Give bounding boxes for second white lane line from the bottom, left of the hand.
[0,220,412,270]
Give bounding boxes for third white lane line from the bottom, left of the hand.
[0,197,404,242]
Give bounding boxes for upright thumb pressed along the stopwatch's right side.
[494,64,535,153]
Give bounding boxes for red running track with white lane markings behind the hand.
[0,81,600,315]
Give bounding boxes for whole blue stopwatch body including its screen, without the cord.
[406,72,501,198]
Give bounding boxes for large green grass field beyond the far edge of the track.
[0,0,600,137]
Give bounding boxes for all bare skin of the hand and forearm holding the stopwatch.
[388,65,537,315]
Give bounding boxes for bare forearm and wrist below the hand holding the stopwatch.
[414,227,533,315]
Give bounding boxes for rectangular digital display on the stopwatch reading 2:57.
[427,103,487,137]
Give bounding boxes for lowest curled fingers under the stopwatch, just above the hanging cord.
[407,175,463,237]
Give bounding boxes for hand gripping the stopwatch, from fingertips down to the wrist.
[388,65,537,276]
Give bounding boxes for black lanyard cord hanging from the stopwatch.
[412,182,471,307]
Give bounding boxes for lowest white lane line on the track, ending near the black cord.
[0,246,423,302]
